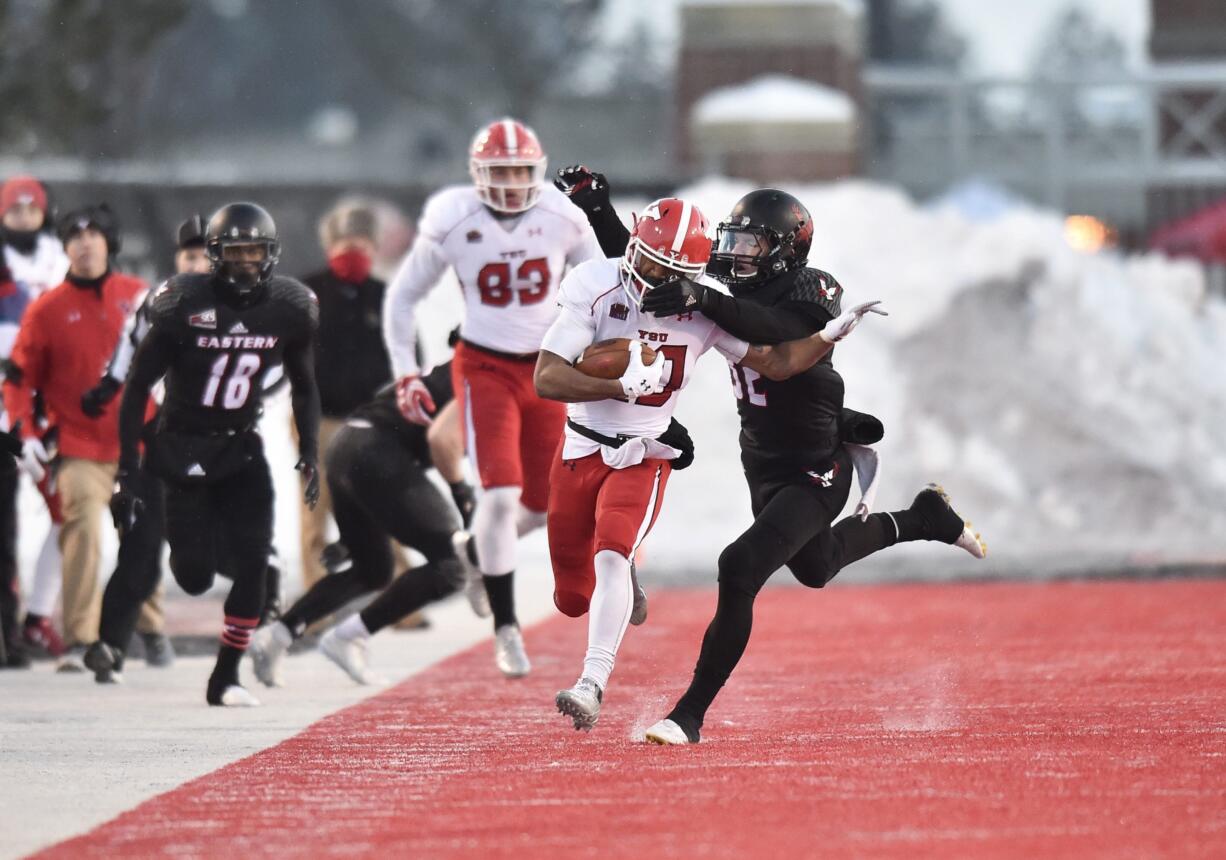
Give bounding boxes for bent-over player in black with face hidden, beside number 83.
[251,362,489,687]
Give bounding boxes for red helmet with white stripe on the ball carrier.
[622,198,711,307]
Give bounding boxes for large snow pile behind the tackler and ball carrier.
[652,180,1226,574]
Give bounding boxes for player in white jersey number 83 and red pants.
[384,119,603,677]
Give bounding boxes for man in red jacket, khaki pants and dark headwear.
[4,206,162,671]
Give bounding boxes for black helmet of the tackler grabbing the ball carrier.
[706,188,813,296]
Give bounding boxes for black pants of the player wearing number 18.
[166,450,273,626]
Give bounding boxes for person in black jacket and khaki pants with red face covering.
[300,201,426,623]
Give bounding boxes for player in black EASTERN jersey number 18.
[112,202,319,707]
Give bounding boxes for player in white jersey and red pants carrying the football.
[536,198,880,730]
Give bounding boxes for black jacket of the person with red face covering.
[303,269,391,418]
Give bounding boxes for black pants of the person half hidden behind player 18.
[98,469,166,651]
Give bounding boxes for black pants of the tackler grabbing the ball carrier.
[669,448,894,732]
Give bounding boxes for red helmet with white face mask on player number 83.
[468,119,546,213]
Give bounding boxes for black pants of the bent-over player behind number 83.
[281,424,462,635]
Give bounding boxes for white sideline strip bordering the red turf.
[0,569,554,858]
